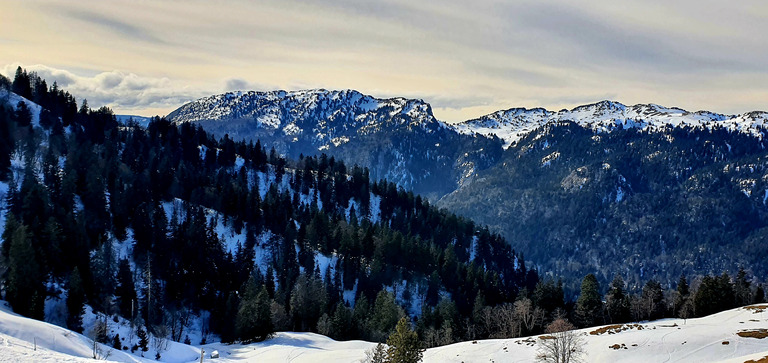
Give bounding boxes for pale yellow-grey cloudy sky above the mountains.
[0,0,768,122]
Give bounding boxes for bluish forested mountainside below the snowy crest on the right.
[439,121,768,285]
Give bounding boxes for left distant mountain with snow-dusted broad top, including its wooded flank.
[168,89,502,199]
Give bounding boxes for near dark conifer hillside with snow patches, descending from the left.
[0,70,538,350]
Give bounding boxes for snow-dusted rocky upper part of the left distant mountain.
[168,89,449,151]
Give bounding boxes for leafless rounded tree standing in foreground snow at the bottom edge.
[536,319,586,363]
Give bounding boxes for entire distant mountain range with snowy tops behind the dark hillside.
[168,90,768,283]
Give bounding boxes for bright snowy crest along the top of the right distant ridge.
[456,101,768,147]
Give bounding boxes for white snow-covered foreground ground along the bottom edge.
[0,302,768,363]
